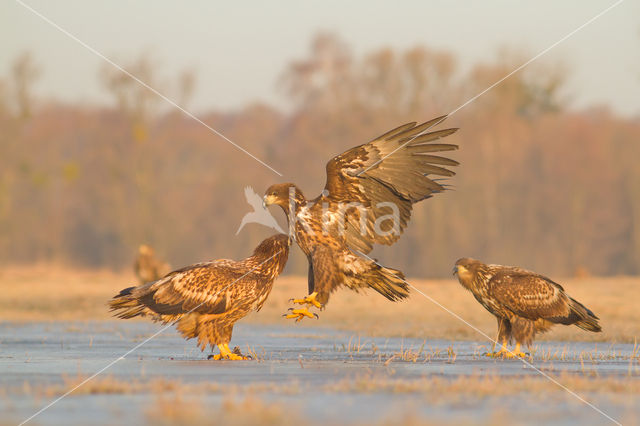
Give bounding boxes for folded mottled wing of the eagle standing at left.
[134,260,246,315]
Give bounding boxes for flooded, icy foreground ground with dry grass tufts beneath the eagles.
[0,321,640,425]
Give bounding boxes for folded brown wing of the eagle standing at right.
[489,268,570,320]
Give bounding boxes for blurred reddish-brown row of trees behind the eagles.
[0,34,640,277]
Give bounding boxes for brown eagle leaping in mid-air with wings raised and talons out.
[263,116,458,318]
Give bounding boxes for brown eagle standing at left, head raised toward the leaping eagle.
[109,234,290,360]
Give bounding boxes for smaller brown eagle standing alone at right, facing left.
[453,257,602,358]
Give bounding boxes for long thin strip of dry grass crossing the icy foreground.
[13,369,640,402]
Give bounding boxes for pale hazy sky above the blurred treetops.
[0,0,640,116]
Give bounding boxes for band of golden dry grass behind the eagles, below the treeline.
[0,265,640,343]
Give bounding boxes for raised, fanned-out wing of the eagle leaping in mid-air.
[325,116,458,253]
